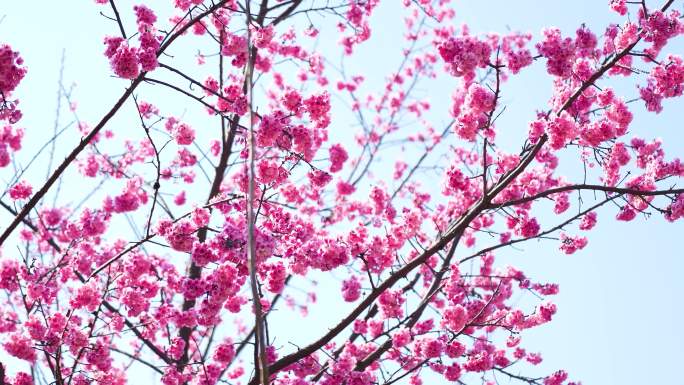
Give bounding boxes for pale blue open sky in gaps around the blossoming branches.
[0,0,684,385]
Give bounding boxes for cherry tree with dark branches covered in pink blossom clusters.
[0,0,684,385]
